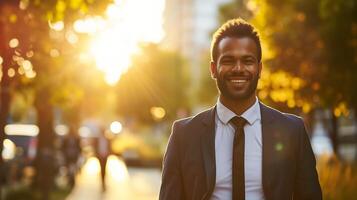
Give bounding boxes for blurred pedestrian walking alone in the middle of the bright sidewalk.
[96,128,110,192]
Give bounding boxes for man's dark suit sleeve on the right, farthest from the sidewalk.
[293,119,322,200]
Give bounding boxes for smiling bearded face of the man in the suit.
[211,37,262,100]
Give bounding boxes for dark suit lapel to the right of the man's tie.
[260,103,276,200]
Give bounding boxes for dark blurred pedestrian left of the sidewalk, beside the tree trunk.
[62,127,81,187]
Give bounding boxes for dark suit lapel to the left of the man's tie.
[201,107,216,199]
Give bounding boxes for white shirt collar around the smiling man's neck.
[217,98,261,125]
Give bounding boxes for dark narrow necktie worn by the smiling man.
[231,116,247,200]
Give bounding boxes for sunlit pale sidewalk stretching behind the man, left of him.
[66,156,161,200]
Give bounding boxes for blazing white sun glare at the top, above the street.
[80,0,164,85]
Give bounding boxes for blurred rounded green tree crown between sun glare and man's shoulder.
[117,44,187,122]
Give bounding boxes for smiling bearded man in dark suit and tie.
[160,19,322,200]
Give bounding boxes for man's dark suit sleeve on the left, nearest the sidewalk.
[159,123,184,200]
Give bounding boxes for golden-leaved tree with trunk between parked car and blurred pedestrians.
[23,0,109,198]
